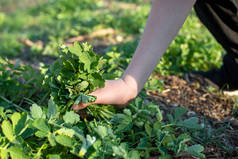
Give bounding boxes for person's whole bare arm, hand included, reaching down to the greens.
[73,0,195,109]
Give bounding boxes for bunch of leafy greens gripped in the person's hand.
[45,43,110,115]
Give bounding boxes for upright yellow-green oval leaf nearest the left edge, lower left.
[1,120,15,142]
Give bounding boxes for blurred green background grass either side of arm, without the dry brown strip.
[0,0,224,75]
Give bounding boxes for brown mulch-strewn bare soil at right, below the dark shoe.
[148,76,238,159]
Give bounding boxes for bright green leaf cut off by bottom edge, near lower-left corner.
[7,146,30,159]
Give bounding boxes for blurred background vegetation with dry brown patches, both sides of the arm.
[0,0,224,78]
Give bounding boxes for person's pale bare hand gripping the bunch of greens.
[72,79,137,110]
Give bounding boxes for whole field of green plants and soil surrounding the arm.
[0,0,238,159]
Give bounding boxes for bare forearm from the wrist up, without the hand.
[122,0,195,93]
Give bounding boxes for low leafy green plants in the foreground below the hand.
[0,98,205,159]
